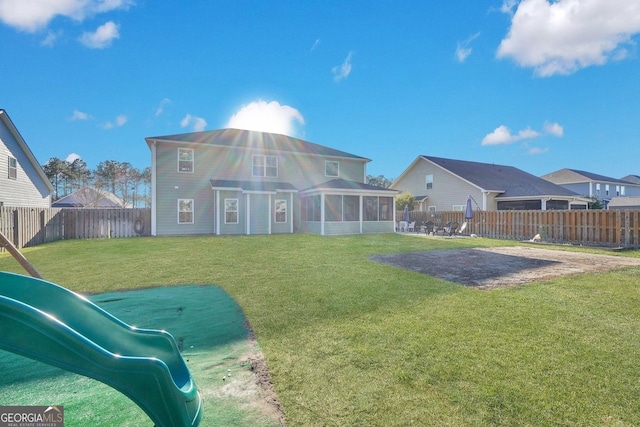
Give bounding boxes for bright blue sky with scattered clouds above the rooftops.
[0,0,640,178]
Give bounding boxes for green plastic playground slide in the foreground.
[0,272,202,427]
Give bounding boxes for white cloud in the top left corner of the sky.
[0,0,134,32]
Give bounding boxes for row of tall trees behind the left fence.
[42,157,151,208]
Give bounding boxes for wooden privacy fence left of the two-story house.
[0,207,151,250]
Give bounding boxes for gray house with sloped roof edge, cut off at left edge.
[0,109,53,208]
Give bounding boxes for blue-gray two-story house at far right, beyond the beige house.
[541,169,640,208]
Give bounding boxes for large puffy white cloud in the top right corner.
[497,0,640,77]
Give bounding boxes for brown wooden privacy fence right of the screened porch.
[396,210,640,249]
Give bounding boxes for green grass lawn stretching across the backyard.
[0,234,640,426]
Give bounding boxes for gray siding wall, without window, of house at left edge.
[0,120,51,208]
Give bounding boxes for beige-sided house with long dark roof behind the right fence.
[391,156,588,211]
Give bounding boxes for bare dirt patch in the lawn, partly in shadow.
[371,246,640,290]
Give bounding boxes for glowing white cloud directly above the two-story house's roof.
[225,99,304,136]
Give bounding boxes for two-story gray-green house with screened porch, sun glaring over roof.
[145,129,397,235]
